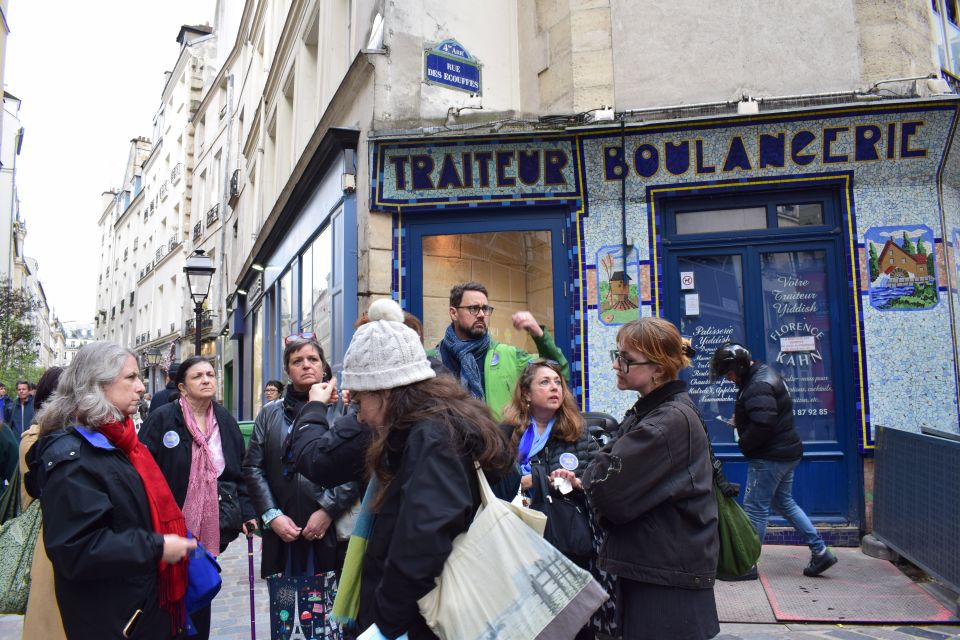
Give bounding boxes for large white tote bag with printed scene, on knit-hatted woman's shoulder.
[419,469,607,640]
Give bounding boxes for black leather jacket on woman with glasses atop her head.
[243,391,360,578]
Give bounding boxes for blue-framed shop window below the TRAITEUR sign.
[400,209,571,368]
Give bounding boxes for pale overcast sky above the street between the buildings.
[4,0,217,323]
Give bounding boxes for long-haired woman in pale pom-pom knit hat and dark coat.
[292,303,515,640]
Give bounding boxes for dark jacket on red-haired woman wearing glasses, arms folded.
[583,380,719,589]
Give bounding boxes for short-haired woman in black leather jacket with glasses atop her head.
[243,333,359,578]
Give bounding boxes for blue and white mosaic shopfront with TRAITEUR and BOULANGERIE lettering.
[370,99,960,476]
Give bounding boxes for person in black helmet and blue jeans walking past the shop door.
[710,342,837,580]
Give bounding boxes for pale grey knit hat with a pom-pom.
[341,300,437,391]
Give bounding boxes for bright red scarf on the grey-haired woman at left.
[99,416,187,632]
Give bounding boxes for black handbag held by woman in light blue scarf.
[530,464,593,558]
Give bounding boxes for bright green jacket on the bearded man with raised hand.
[427,328,570,420]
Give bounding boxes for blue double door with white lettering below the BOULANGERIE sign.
[663,238,859,525]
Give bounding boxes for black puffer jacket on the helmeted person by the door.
[734,363,803,460]
